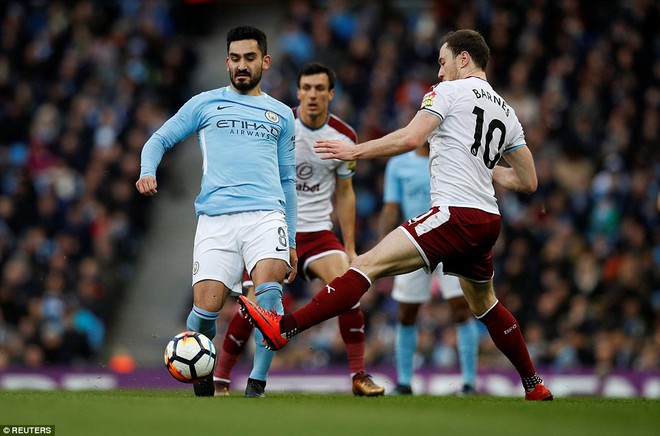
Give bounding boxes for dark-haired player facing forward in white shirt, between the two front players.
[214,63,385,396]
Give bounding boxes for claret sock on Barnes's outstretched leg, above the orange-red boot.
[280,268,371,337]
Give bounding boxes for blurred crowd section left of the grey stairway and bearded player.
[0,0,196,368]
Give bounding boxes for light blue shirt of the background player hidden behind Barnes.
[383,151,431,220]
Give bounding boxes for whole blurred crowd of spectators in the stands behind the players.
[0,0,660,373]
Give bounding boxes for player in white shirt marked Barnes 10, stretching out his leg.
[239,29,553,400]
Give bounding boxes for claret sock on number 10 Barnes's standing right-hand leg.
[478,301,536,379]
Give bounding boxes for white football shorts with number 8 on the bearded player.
[192,211,291,295]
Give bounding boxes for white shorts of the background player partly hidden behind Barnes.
[392,264,463,304]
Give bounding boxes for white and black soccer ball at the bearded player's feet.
[165,332,216,383]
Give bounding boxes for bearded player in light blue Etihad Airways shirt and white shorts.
[136,26,298,397]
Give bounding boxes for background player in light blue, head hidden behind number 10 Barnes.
[379,144,480,395]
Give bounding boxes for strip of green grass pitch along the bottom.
[0,389,660,436]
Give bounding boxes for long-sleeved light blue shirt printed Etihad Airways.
[140,86,297,247]
